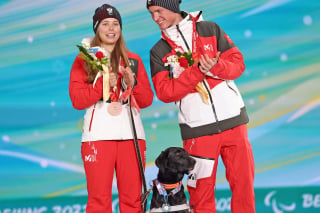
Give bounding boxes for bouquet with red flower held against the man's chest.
[163,48,209,104]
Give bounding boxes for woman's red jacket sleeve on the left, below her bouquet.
[69,55,103,110]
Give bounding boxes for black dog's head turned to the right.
[155,147,196,183]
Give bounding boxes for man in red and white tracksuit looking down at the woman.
[147,0,255,213]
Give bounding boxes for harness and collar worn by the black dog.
[150,179,189,213]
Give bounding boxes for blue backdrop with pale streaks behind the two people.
[0,0,320,212]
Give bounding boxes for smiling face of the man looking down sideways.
[149,6,182,30]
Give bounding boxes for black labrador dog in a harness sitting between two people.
[149,147,196,213]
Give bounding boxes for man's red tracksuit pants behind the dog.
[184,125,255,213]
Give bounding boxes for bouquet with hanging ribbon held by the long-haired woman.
[77,39,110,101]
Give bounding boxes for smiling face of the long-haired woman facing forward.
[97,18,121,52]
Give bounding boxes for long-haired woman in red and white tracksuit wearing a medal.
[69,4,153,213]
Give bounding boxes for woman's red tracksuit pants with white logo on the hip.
[81,140,146,213]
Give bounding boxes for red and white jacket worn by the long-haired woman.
[69,52,153,142]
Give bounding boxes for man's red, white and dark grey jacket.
[150,13,249,139]
